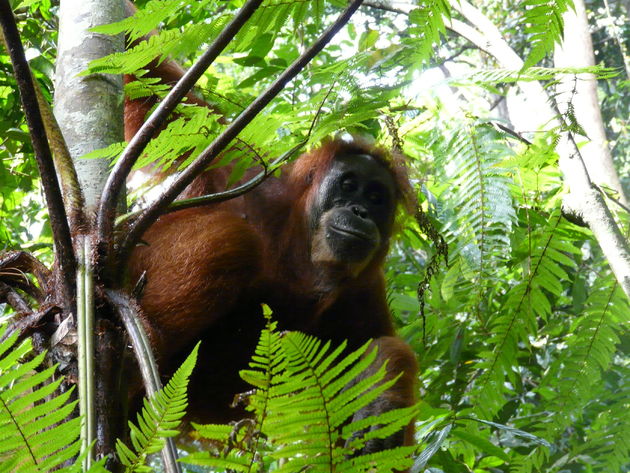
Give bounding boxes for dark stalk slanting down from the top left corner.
[0,0,76,304]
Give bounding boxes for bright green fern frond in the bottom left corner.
[0,326,81,473]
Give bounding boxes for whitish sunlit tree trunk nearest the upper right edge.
[554,0,628,205]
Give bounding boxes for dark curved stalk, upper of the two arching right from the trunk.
[97,0,262,267]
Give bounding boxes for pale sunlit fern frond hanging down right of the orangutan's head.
[438,122,516,323]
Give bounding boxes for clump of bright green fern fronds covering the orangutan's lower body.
[185,314,418,473]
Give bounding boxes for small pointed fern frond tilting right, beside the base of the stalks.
[116,345,199,472]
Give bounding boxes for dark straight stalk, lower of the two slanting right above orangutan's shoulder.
[116,0,363,272]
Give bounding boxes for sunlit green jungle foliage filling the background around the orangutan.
[0,0,630,473]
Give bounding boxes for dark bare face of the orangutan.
[310,154,395,263]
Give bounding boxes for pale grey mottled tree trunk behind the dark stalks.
[55,0,124,215]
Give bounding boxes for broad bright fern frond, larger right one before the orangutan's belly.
[265,332,414,472]
